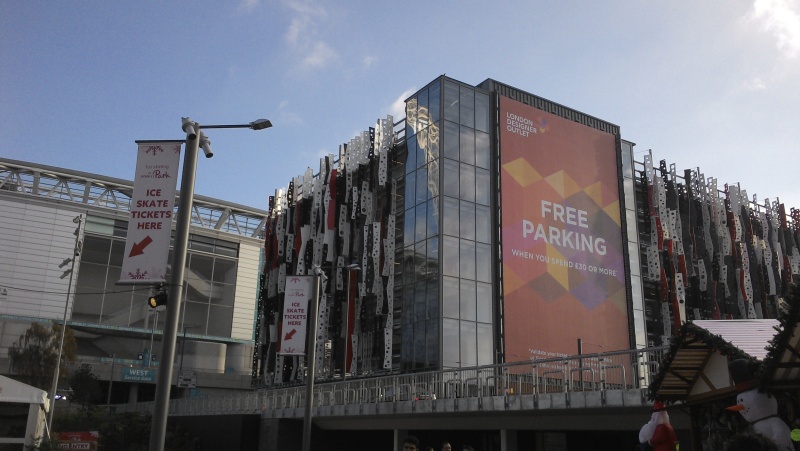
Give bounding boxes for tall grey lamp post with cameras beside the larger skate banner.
[149,117,272,451]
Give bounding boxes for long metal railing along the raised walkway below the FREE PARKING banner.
[117,347,667,415]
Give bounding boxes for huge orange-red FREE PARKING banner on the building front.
[500,97,630,361]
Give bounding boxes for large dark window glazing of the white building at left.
[72,216,238,337]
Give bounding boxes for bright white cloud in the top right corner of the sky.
[748,0,800,58]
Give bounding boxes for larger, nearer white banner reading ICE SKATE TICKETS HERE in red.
[117,141,183,284]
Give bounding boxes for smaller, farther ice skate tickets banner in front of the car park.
[278,276,314,355]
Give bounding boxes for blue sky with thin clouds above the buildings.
[0,0,800,209]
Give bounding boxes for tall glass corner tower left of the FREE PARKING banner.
[401,78,494,370]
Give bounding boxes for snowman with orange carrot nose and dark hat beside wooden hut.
[727,359,794,451]
